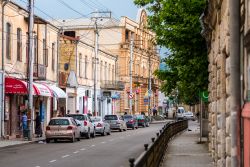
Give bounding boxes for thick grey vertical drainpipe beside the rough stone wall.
[229,0,241,167]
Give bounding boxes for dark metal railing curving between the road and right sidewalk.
[129,120,188,167]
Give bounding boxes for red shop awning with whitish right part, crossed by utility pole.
[5,77,52,96]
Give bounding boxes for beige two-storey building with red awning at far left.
[1,2,65,138]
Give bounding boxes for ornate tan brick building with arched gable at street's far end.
[55,10,160,114]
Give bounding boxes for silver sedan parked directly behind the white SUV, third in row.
[91,117,111,136]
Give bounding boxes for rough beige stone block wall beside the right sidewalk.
[205,0,231,166]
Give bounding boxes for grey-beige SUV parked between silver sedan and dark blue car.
[104,115,127,132]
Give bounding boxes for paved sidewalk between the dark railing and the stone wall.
[162,121,214,167]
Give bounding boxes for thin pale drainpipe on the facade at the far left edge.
[0,0,10,137]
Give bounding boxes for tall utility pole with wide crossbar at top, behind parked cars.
[92,11,111,116]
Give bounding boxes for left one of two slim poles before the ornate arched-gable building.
[129,36,134,114]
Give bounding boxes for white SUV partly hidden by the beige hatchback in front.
[67,114,95,139]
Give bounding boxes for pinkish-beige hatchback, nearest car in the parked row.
[45,117,80,143]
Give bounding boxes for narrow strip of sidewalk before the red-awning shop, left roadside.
[0,137,45,149]
